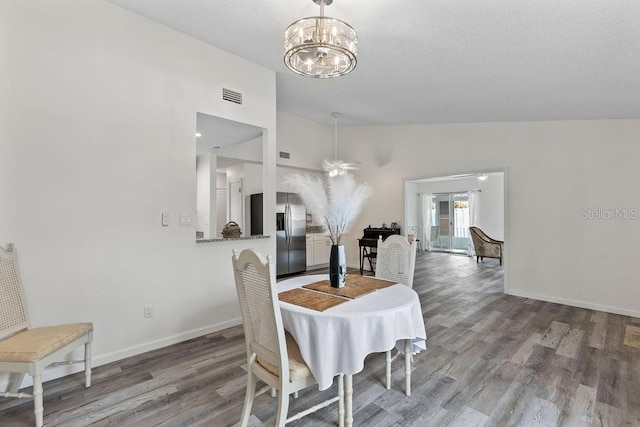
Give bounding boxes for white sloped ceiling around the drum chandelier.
[109,0,640,125]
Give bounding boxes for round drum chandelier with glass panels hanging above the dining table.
[284,0,358,79]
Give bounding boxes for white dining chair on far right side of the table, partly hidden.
[376,235,417,396]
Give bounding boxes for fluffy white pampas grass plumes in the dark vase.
[285,172,371,245]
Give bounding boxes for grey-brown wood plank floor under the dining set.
[0,253,640,426]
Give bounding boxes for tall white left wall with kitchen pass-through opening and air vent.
[0,0,276,386]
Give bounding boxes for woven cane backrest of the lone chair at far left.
[0,248,29,339]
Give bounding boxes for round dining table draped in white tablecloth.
[277,274,427,426]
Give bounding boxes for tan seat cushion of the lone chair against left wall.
[0,322,93,363]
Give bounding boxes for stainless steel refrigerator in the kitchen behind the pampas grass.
[276,193,307,276]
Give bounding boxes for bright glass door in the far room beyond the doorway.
[430,192,471,253]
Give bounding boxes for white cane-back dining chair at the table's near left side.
[232,249,344,426]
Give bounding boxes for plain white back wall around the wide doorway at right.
[340,120,640,317]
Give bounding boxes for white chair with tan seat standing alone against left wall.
[0,246,93,427]
